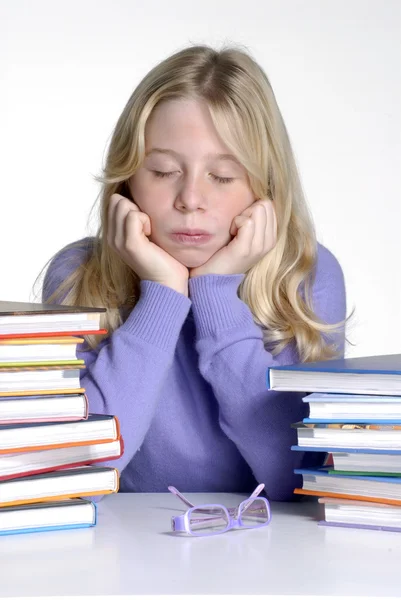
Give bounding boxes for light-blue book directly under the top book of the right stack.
[302,392,401,423]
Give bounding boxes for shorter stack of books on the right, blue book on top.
[267,354,401,531]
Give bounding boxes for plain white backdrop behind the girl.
[0,0,401,356]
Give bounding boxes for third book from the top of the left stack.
[0,365,85,396]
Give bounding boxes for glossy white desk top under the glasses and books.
[0,493,401,598]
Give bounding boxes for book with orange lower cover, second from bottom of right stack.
[294,467,401,506]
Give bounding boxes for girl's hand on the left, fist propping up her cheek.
[107,194,189,296]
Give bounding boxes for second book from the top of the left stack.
[0,335,84,365]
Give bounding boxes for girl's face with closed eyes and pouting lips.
[129,100,255,268]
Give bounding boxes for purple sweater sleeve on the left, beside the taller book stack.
[43,239,191,471]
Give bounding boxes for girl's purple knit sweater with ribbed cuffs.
[43,238,346,500]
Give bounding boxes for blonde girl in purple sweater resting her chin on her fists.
[43,46,346,500]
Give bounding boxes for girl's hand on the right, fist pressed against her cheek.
[190,200,277,277]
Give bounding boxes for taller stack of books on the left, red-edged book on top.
[0,302,123,535]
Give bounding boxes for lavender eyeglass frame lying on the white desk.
[168,483,271,537]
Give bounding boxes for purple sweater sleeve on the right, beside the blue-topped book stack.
[189,247,346,500]
